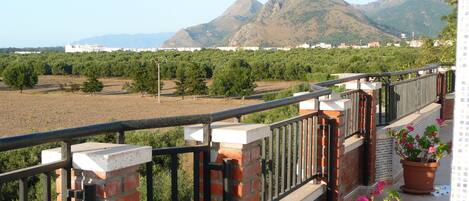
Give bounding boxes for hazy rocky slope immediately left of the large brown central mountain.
[163,0,262,47]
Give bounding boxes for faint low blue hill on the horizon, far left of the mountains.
[72,33,174,48]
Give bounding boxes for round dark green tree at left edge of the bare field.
[3,64,38,93]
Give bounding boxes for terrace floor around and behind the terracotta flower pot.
[382,121,453,201]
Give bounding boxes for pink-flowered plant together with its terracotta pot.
[388,119,450,194]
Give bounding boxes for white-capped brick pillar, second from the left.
[184,122,271,201]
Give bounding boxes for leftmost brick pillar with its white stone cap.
[42,143,151,201]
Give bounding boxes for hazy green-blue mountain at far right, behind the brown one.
[357,0,451,37]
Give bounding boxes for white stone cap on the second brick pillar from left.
[184,122,272,144]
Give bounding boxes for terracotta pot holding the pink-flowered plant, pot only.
[401,161,439,194]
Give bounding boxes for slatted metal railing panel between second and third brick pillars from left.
[261,112,326,200]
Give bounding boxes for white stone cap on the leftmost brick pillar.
[41,142,152,172]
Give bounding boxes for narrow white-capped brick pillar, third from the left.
[320,99,351,201]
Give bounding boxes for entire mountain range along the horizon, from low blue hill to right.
[75,0,452,48]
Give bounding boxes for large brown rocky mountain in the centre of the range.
[228,0,395,46]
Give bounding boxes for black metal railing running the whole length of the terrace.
[0,64,454,201]
